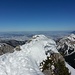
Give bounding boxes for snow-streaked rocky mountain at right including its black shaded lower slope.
[57,34,75,68]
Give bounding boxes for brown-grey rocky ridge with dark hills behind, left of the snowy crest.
[0,40,26,55]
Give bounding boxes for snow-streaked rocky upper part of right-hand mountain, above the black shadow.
[57,34,75,56]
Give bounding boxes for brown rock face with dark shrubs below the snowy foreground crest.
[40,53,66,75]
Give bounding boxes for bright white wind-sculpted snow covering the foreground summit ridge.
[0,35,58,75]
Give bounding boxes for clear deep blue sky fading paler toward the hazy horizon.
[0,0,75,31]
